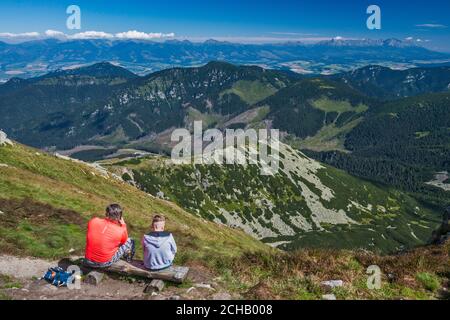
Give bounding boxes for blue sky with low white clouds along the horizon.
[0,0,450,52]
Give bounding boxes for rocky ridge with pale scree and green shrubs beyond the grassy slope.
[103,144,440,253]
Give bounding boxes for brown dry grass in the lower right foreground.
[223,243,450,299]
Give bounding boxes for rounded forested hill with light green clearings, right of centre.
[257,79,376,151]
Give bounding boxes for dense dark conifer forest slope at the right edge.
[309,92,450,208]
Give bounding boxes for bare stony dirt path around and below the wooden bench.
[0,255,234,300]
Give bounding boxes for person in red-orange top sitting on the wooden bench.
[85,204,135,268]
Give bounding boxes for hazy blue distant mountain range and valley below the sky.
[0,39,450,81]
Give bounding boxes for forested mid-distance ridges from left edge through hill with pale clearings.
[0,62,382,151]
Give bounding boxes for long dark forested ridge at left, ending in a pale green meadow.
[0,62,292,148]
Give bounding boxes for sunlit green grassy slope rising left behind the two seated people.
[0,144,270,263]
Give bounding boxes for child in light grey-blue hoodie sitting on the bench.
[142,214,177,271]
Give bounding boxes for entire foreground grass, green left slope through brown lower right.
[0,144,450,299]
